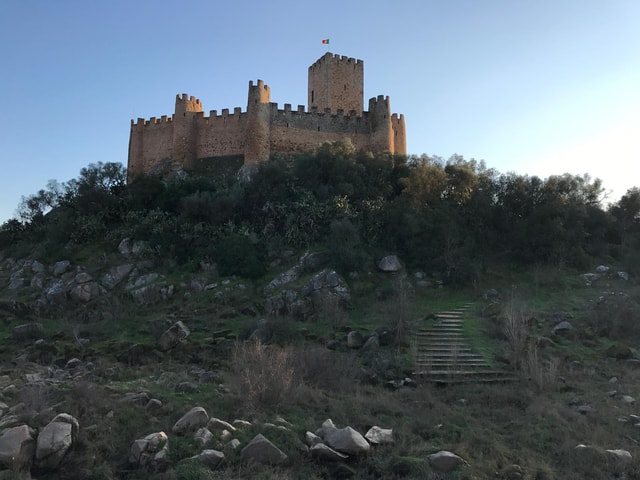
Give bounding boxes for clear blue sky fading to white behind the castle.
[0,0,640,222]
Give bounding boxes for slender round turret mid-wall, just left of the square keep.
[244,80,271,165]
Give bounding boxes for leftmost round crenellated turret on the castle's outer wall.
[172,93,203,168]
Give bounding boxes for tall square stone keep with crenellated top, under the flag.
[308,53,364,114]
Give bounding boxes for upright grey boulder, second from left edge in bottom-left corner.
[36,414,79,470]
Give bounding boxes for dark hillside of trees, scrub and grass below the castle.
[0,138,640,480]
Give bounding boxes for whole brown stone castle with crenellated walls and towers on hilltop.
[128,53,406,179]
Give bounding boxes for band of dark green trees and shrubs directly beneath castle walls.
[0,142,640,282]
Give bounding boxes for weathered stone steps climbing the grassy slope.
[414,305,517,384]
